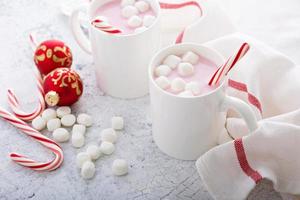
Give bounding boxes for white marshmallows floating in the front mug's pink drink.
[154,51,201,97]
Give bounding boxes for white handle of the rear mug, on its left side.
[71,6,92,54]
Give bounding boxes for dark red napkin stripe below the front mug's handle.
[234,138,262,184]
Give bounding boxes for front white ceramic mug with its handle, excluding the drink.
[149,43,257,160]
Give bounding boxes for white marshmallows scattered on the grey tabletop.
[32,106,128,179]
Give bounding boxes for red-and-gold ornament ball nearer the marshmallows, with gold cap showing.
[43,68,83,106]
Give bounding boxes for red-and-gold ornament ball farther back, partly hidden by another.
[34,40,73,75]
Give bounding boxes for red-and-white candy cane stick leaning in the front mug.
[208,43,250,86]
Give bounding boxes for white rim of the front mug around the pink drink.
[148,43,226,99]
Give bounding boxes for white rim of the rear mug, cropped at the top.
[88,0,161,38]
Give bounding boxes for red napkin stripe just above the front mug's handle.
[228,79,262,114]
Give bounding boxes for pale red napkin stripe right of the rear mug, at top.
[159,1,203,44]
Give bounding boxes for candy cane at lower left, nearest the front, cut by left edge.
[0,107,64,171]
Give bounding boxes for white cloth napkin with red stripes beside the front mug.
[159,1,300,200]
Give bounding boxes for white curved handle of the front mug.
[221,95,258,132]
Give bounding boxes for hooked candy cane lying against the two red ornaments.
[7,74,46,121]
